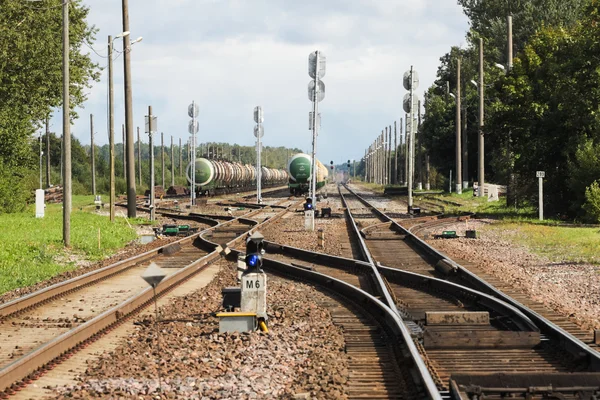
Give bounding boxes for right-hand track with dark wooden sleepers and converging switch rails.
[340,184,600,399]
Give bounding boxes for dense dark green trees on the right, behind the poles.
[421,0,600,222]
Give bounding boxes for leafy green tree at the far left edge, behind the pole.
[0,0,98,213]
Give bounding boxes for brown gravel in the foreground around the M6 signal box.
[56,261,348,399]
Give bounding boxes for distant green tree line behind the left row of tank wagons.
[26,132,300,200]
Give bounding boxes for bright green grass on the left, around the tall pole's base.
[0,196,145,293]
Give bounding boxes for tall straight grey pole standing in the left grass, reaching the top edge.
[62,1,72,247]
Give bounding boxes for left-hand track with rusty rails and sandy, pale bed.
[0,200,293,398]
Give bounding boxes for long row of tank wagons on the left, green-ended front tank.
[186,158,287,196]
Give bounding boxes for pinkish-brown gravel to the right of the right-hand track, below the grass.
[428,220,600,330]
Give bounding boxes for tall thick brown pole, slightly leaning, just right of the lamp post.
[123,0,136,218]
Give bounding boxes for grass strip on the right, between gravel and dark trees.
[356,184,600,264]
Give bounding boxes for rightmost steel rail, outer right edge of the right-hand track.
[346,183,600,369]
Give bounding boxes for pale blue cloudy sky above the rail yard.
[51,0,468,164]
